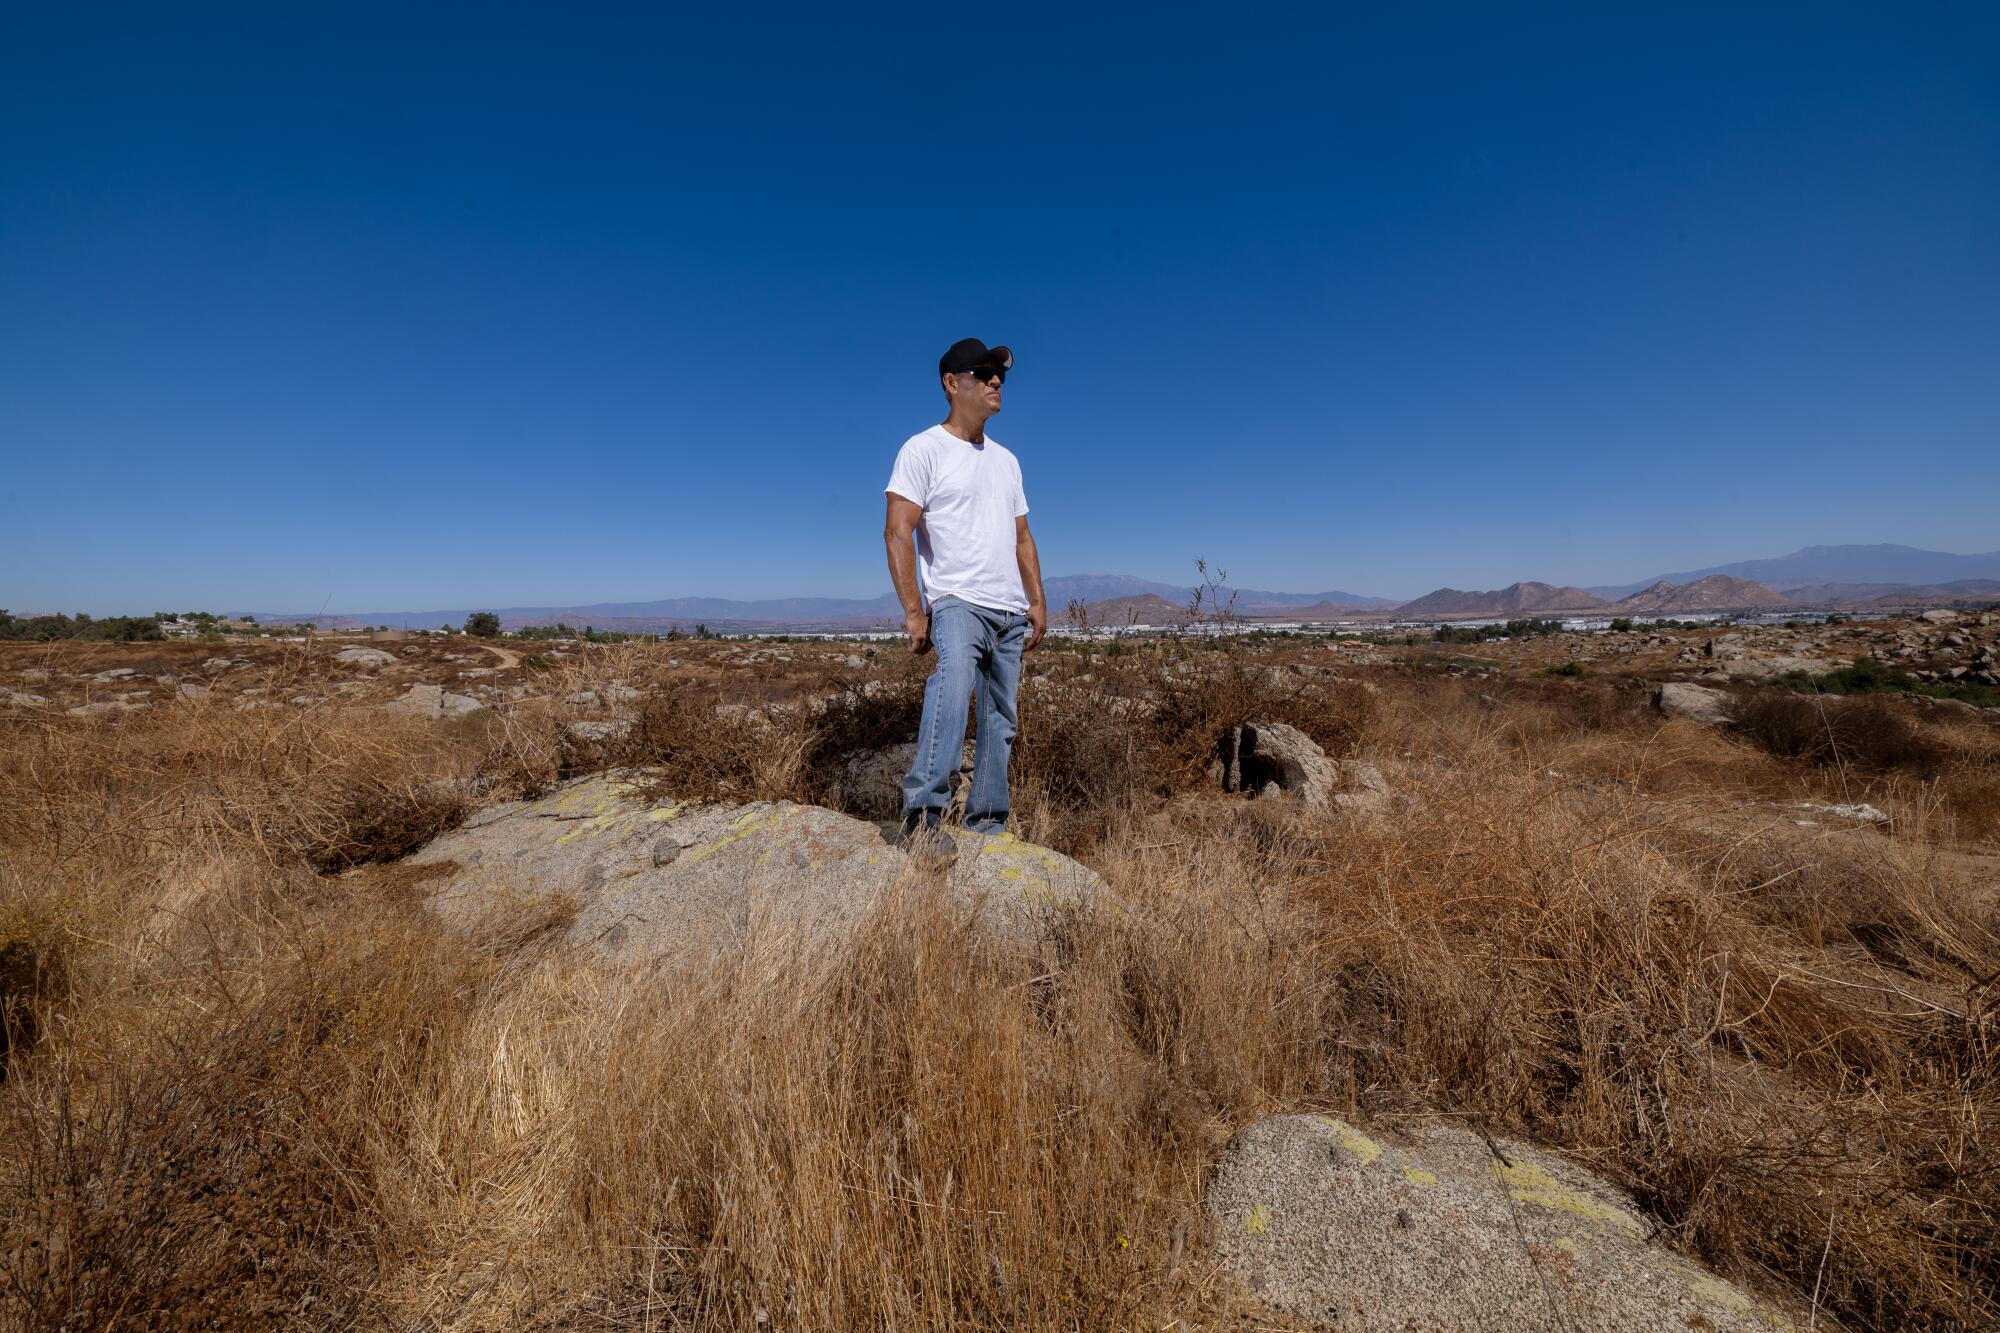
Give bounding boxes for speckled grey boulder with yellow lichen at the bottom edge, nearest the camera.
[1208,1115,1798,1333]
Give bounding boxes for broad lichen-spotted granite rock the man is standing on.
[404,775,1108,961]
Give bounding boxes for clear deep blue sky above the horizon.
[0,4,2000,612]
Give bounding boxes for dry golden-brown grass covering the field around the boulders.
[0,650,2000,1329]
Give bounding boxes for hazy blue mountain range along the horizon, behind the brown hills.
[232,544,2000,630]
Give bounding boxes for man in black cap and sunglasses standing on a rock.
[882,338,1048,865]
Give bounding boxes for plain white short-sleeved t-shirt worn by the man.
[884,426,1028,612]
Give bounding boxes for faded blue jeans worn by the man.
[902,596,1028,833]
